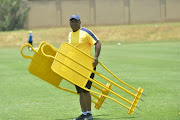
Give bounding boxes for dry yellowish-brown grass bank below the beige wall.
[0,23,180,47]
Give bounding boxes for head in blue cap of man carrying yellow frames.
[69,15,81,32]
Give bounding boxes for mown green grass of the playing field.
[0,41,180,120]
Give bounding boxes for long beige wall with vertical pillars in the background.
[25,0,180,28]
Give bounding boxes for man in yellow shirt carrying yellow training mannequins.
[69,15,101,120]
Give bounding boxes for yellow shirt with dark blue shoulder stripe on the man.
[68,27,99,55]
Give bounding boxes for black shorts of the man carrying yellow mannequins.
[75,68,96,93]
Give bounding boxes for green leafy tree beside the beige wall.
[0,0,29,31]
